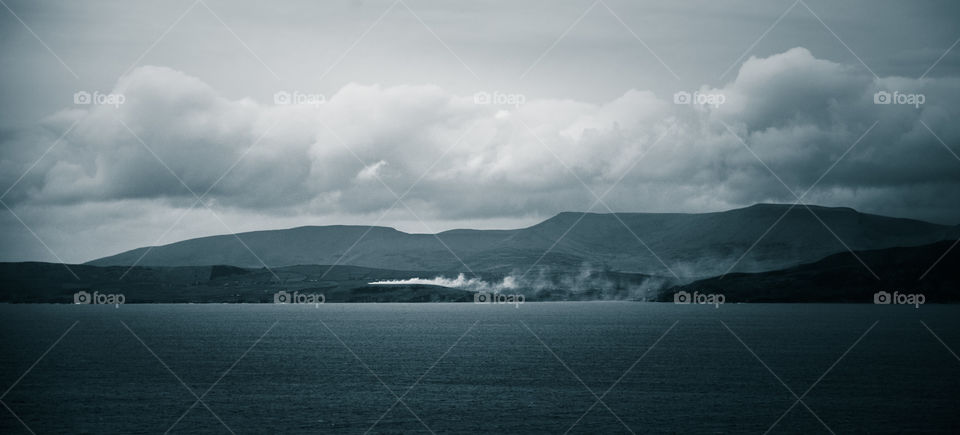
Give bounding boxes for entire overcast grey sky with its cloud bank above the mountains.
[0,0,960,263]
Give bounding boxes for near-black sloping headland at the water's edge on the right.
[659,240,960,303]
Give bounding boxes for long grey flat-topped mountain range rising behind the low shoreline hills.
[87,204,960,278]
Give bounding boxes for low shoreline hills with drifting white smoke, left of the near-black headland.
[0,262,660,304]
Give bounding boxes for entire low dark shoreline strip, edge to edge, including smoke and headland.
[0,240,960,303]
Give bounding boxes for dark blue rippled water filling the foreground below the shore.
[0,302,960,434]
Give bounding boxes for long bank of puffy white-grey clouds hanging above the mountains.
[0,48,960,262]
